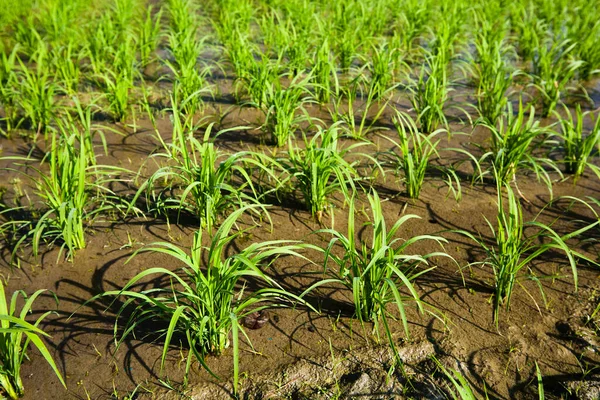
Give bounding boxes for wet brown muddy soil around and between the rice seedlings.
[0,76,600,399]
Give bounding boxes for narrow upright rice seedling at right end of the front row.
[458,177,598,325]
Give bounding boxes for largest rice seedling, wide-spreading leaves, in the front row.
[88,206,316,391]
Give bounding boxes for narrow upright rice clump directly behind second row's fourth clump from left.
[408,54,450,133]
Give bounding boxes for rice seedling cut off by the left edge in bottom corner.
[0,281,67,399]
